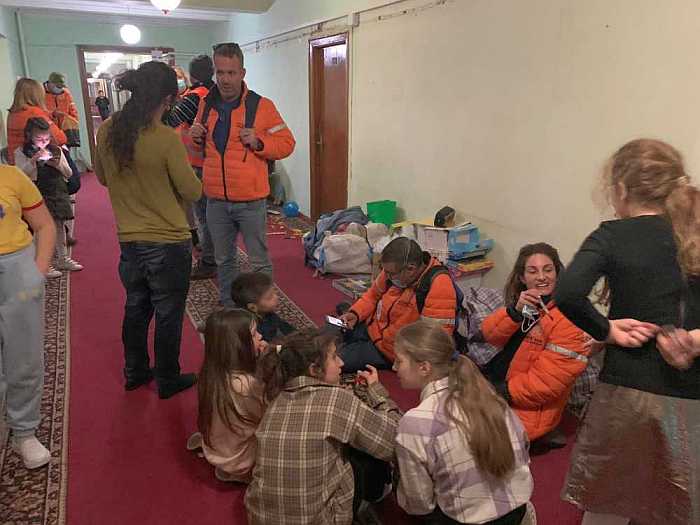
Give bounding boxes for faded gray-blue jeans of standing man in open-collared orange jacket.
[207,199,272,308]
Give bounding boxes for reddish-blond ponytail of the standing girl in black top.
[664,183,700,276]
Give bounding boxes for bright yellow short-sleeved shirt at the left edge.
[0,166,43,255]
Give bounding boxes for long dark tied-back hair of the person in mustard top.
[107,61,177,170]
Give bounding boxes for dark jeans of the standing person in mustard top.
[119,240,192,383]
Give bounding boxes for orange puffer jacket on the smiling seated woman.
[481,302,589,440]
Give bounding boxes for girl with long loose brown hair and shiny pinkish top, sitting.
[187,309,267,483]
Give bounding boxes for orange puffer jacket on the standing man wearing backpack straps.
[196,83,296,202]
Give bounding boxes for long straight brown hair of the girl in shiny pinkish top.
[197,309,256,445]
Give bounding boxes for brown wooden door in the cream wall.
[310,34,348,219]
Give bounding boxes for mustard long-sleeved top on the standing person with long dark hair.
[95,119,202,243]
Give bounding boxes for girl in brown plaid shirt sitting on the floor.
[245,330,401,525]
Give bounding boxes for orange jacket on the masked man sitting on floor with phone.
[350,254,457,362]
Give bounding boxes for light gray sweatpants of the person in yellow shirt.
[0,244,44,437]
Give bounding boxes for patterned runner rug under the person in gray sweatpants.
[0,270,70,525]
